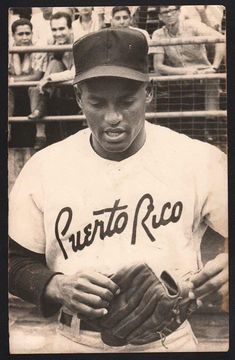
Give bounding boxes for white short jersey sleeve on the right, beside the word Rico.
[202,147,228,237]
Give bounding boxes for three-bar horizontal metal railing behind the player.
[9,35,227,129]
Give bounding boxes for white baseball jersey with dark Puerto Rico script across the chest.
[9,122,227,276]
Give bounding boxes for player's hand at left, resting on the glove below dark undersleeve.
[46,271,119,319]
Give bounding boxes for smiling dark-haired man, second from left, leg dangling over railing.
[28,12,78,147]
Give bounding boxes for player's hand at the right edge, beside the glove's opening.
[191,253,228,310]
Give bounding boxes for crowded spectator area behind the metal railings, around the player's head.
[8,5,227,151]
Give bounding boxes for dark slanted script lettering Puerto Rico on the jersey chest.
[55,194,183,259]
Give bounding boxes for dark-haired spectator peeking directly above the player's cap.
[111,6,150,43]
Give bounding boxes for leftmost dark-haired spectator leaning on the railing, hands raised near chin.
[8,19,47,146]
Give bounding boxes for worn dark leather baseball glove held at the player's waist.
[85,264,197,346]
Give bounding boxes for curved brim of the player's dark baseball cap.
[73,65,149,85]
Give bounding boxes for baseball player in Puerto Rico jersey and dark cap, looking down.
[9,29,228,353]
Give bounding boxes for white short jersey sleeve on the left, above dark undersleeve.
[9,156,45,254]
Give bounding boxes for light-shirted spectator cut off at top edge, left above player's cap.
[72,7,104,41]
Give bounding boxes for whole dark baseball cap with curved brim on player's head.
[73,28,149,84]
